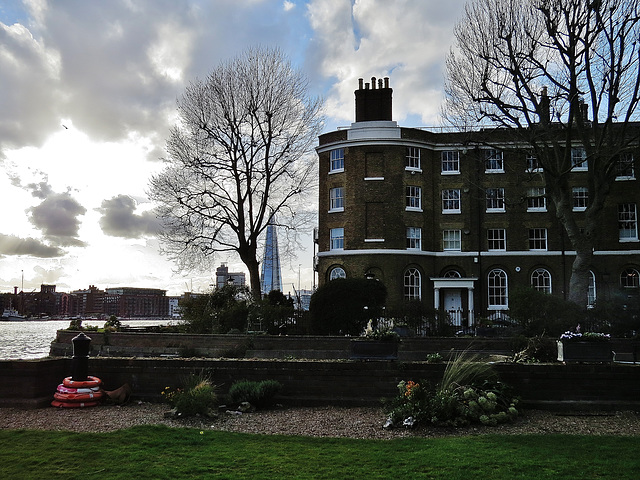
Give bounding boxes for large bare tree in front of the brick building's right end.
[444,0,640,305]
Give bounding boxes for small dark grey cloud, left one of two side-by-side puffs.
[28,193,87,246]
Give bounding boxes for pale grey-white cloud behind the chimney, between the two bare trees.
[308,0,464,125]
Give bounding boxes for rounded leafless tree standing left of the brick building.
[149,47,322,298]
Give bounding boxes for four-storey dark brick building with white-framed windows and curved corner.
[316,78,640,326]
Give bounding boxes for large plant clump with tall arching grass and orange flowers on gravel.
[385,353,518,428]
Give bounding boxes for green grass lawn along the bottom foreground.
[0,426,640,480]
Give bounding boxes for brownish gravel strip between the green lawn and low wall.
[0,402,640,439]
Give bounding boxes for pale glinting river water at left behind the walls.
[0,319,175,360]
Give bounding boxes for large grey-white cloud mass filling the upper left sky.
[0,0,316,160]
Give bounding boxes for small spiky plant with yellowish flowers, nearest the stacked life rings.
[160,374,217,417]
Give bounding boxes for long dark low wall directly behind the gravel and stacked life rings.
[0,357,640,409]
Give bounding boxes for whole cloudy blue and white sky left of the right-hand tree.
[0,0,464,295]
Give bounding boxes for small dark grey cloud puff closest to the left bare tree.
[98,195,160,238]
